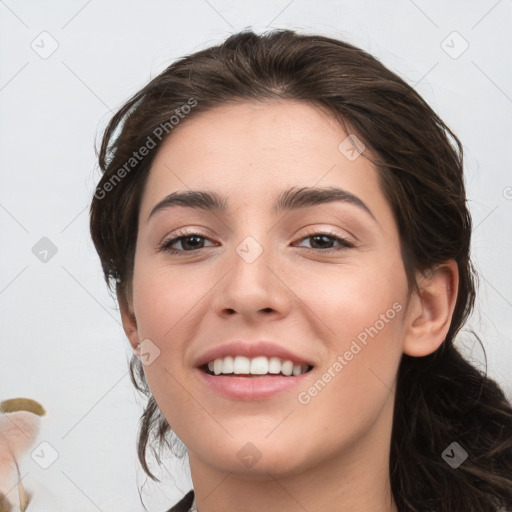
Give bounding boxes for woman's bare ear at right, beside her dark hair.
[404,259,459,357]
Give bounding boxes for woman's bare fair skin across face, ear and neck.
[120,101,458,512]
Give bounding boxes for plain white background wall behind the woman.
[0,0,512,512]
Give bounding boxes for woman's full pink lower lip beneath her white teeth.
[197,369,313,401]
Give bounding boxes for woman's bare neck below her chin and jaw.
[189,396,397,512]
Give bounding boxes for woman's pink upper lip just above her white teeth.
[195,340,313,367]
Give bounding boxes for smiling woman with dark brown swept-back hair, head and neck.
[91,30,512,512]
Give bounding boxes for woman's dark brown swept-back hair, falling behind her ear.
[90,30,512,512]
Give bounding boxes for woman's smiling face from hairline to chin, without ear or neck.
[127,101,407,477]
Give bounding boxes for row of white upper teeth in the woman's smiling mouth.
[203,356,308,376]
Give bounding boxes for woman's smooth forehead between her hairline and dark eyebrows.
[141,100,386,220]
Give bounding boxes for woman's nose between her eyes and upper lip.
[214,236,292,321]
